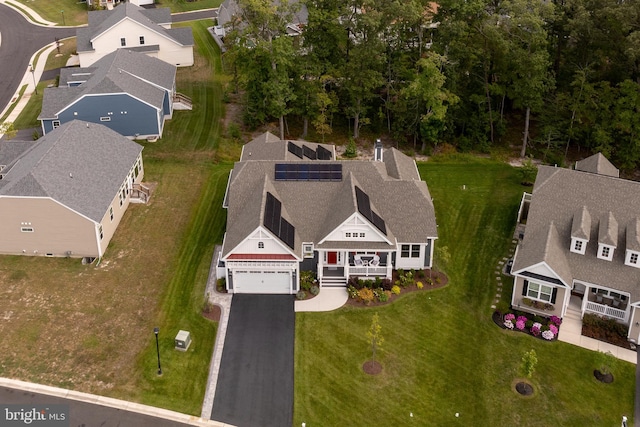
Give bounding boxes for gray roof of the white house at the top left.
[76,2,193,52]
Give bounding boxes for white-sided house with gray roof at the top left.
[76,3,194,67]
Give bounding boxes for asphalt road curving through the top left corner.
[0,4,76,117]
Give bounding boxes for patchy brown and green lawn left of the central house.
[0,21,231,415]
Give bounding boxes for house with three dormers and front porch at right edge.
[511,154,640,342]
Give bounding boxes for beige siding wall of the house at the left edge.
[0,197,99,257]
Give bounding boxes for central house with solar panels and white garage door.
[217,133,437,294]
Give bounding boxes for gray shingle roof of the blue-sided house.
[38,49,176,119]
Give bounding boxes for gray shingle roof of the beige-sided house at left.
[0,120,142,222]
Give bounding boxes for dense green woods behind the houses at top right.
[225,0,640,170]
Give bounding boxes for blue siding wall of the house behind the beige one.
[42,94,163,137]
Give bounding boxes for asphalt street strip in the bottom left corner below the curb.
[0,387,194,427]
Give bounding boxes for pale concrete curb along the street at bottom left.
[0,378,232,427]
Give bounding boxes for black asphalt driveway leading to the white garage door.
[211,295,295,427]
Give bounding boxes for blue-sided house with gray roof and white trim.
[38,49,191,139]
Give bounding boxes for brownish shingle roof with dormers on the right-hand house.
[513,158,640,301]
